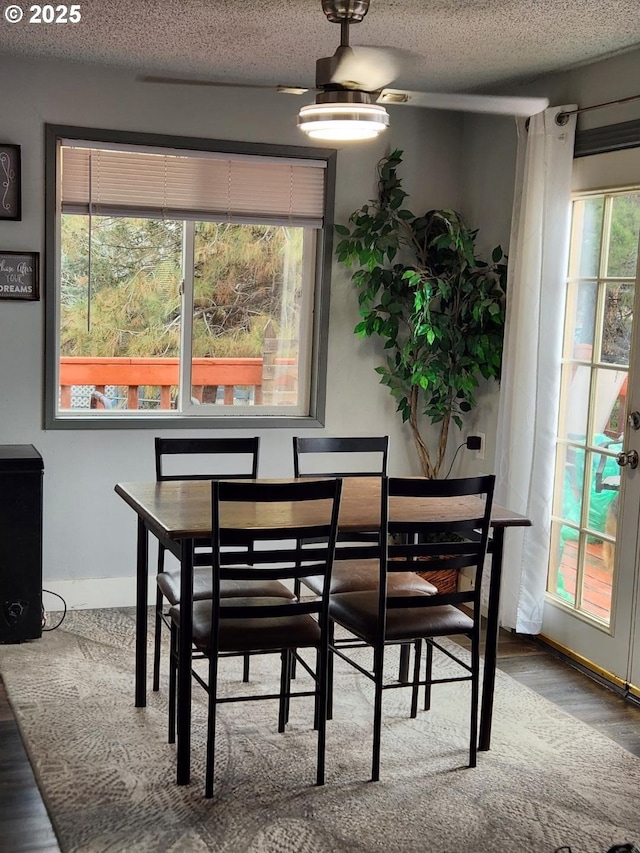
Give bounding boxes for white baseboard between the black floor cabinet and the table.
[42,574,156,612]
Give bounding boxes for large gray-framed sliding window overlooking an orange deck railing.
[46,126,335,428]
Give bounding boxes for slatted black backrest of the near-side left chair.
[211,479,342,627]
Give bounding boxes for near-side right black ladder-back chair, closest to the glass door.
[330,475,495,781]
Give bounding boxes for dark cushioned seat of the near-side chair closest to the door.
[329,590,473,643]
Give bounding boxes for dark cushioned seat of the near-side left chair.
[169,596,320,654]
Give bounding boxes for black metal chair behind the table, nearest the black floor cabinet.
[153,436,293,690]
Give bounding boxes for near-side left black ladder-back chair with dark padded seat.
[169,479,342,797]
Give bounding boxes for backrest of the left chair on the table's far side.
[155,436,260,480]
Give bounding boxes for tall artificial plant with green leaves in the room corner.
[335,150,507,478]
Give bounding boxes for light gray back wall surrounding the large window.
[0,57,462,607]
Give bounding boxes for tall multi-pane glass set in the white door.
[547,187,640,626]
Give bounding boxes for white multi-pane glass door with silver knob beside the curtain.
[542,152,640,686]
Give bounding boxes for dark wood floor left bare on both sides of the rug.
[0,632,640,853]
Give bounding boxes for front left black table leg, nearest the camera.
[177,539,193,785]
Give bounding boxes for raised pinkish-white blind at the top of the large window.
[61,141,326,228]
